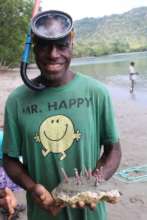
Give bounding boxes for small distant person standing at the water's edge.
[129,62,138,93]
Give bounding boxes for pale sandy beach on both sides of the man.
[0,70,147,220]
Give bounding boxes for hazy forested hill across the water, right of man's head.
[74,7,147,56]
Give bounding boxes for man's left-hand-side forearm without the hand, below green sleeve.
[3,155,36,191]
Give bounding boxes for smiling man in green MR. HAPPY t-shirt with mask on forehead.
[3,11,121,220]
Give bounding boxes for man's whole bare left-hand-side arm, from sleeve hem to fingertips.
[3,154,60,215]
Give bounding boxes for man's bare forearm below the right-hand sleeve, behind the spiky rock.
[94,142,121,180]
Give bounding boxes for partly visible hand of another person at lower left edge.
[0,187,17,219]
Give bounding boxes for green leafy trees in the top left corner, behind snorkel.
[0,0,33,66]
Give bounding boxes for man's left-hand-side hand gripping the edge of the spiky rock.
[31,184,63,215]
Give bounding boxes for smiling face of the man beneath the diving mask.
[34,36,72,82]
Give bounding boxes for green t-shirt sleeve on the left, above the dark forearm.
[2,96,21,158]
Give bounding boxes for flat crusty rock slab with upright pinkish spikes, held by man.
[52,167,120,207]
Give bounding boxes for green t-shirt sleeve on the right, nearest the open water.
[100,90,119,145]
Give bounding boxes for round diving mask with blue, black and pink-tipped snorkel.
[20,1,73,91]
